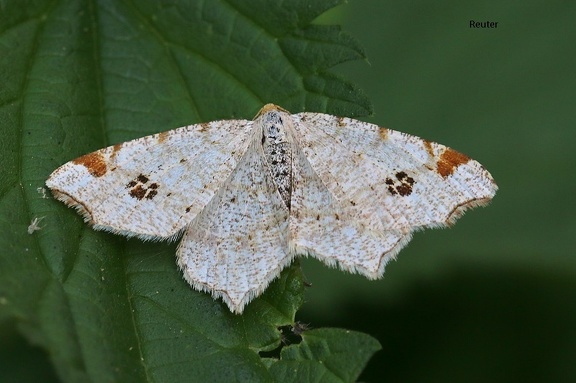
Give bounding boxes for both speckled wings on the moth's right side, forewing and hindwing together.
[291,113,497,278]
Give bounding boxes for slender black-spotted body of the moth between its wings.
[262,113,292,209]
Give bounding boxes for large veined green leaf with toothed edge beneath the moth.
[0,0,370,382]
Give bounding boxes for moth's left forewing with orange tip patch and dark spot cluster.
[46,120,252,239]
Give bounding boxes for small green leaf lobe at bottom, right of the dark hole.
[268,328,381,383]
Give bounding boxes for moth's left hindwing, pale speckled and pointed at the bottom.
[177,132,294,313]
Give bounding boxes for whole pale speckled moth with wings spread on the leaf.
[46,104,497,313]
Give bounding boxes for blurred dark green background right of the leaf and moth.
[300,0,576,382]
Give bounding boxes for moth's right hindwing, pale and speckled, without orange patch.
[290,139,410,279]
